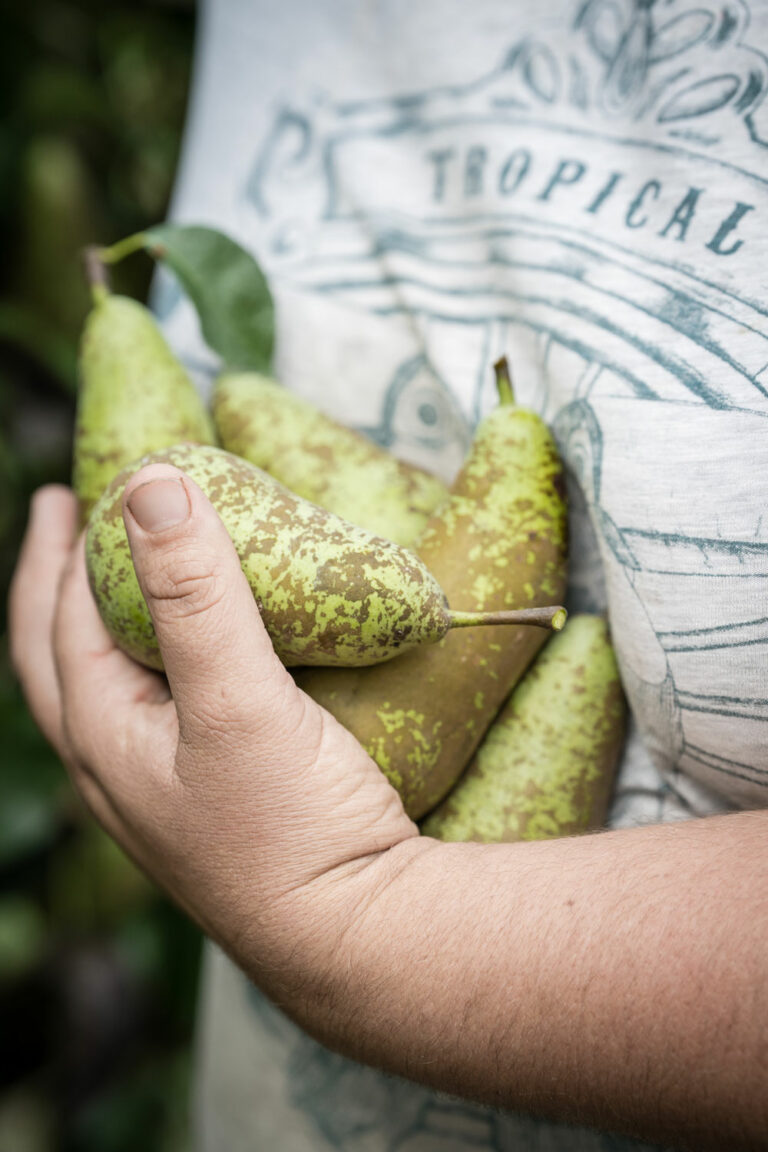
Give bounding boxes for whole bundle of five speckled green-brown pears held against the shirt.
[74,238,625,842]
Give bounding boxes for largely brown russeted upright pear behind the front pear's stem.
[296,404,568,819]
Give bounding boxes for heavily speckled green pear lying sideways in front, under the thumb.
[85,445,462,668]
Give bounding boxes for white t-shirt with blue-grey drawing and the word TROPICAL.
[158,0,768,1152]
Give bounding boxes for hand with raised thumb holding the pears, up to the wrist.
[9,464,417,1002]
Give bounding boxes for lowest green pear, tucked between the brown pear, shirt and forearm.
[421,615,626,843]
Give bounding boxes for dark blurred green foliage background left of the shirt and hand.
[0,0,200,1152]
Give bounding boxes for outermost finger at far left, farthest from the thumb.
[8,485,77,755]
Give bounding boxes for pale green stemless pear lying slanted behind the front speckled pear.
[213,372,448,547]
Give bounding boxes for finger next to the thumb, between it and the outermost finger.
[53,537,176,806]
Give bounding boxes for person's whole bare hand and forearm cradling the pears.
[9,465,768,1152]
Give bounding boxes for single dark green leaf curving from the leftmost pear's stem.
[143,223,274,372]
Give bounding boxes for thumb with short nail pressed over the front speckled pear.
[123,464,299,743]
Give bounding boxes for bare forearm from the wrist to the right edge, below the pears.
[275,812,768,1150]
